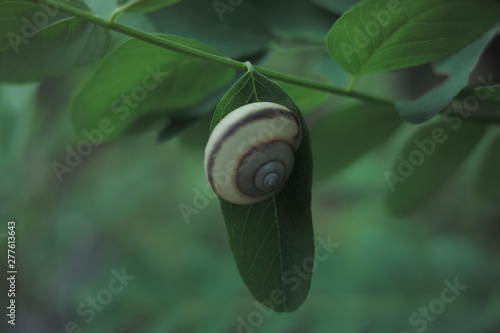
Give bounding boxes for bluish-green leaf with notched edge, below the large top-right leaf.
[396,25,500,124]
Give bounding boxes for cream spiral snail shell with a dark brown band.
[205,102,302,204]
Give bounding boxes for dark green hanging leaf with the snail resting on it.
[211,71,314,312]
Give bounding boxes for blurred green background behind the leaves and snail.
[0,1,500,333]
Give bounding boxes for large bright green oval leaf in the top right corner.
[326,0,500,76]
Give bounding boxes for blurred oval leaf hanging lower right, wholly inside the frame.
[384,119,486,215]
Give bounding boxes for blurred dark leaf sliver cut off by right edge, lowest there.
[475,134,500,204]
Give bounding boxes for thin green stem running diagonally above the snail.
[44,0,394,106]
